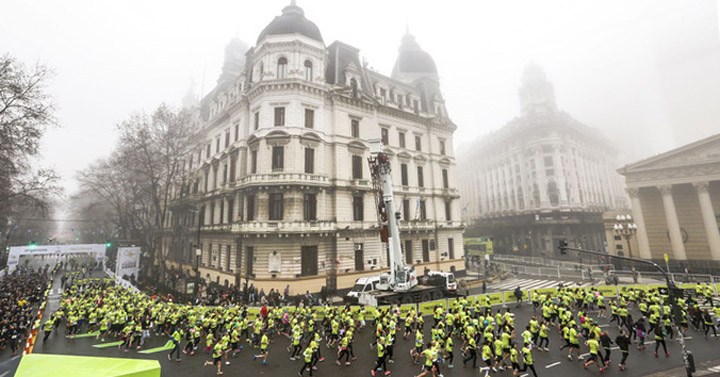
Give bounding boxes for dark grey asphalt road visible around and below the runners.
[0,268,720,377]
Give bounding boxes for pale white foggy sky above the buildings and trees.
[0,0,720,192]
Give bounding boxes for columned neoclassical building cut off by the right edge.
[618,135,720,271]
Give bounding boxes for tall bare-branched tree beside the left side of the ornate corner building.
[78,105,194,274]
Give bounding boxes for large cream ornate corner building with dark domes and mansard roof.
[161,3,463,293]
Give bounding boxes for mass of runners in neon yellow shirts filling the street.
[35,272,720,377]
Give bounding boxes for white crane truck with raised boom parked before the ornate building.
[345,139,457,306]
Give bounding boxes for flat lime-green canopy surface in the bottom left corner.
[15,354,160,377]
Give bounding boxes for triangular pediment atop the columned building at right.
[620,134,720,174]
